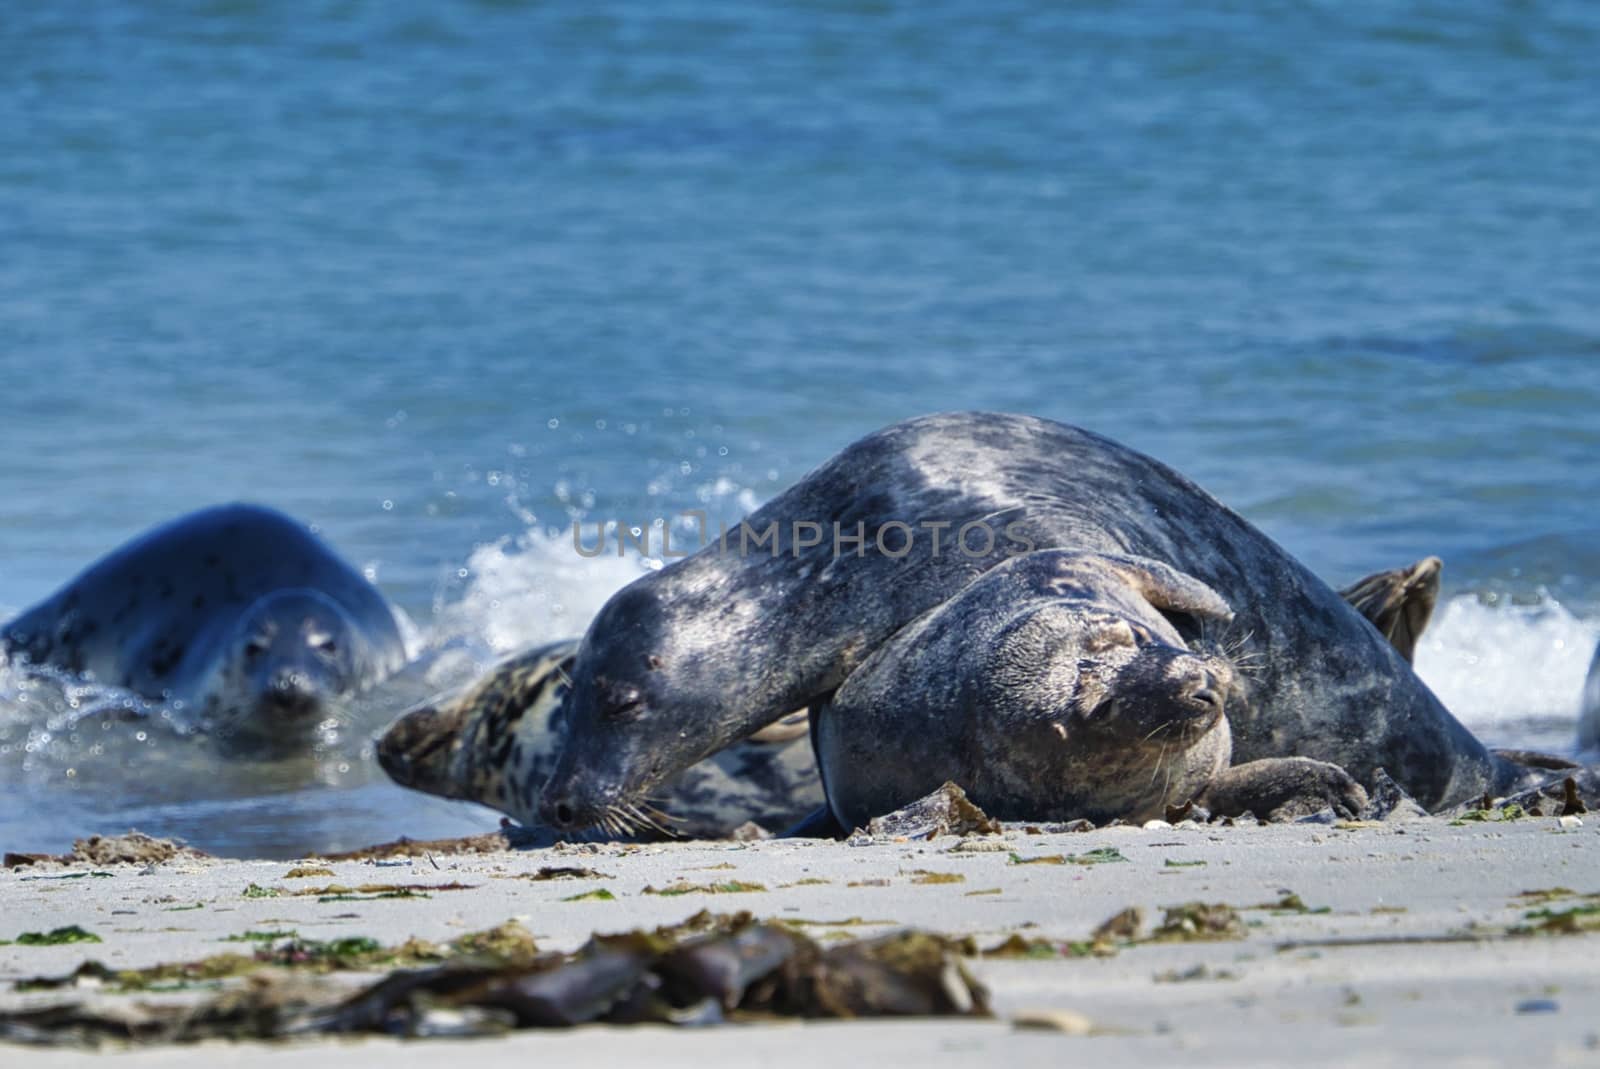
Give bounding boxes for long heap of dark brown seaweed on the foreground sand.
[0,912,990,1047]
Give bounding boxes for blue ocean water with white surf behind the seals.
[0,0,1600,855]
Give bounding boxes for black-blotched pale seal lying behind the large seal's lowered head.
[378,639,822,839]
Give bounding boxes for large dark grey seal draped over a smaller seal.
[541,413,1525,829]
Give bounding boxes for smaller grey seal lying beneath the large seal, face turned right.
[814,549,1366,827]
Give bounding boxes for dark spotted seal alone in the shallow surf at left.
[0,504,405,755]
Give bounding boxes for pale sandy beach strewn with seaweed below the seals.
[0,816,1600,1066]
